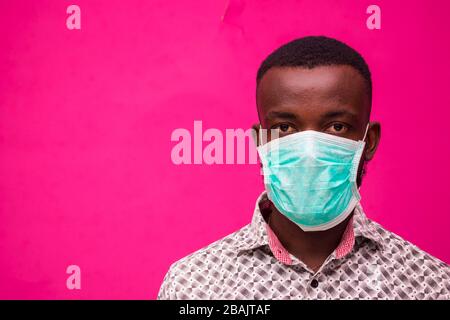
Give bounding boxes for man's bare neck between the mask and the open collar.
[269,204,352,272]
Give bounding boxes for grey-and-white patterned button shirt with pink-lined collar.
[158,192,450,300]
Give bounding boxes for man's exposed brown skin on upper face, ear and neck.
[253,65,380,271]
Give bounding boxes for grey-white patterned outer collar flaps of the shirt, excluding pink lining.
[237,191,383,252]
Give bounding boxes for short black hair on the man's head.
[256,36,372,101]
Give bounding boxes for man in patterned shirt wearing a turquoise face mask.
[158,37,450,299]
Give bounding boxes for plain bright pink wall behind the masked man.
[0,0,450,299]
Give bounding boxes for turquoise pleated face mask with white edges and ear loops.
[257,125,369,231]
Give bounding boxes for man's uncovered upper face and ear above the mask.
[256,65,380,184]
